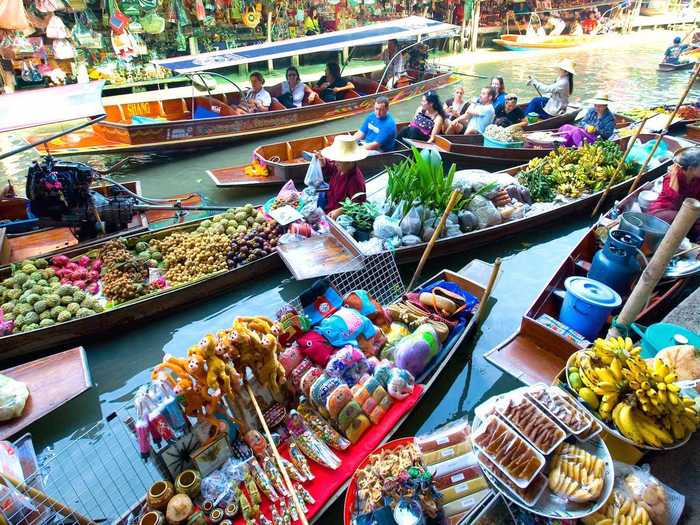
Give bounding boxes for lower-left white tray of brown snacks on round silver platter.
[472,416,545,488]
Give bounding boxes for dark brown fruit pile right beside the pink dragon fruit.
[99,239,151,303]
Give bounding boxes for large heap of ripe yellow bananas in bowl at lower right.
[567,337,699,448]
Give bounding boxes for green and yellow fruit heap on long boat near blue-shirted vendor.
[518,139,635,202]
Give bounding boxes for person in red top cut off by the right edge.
[648,147,700,242]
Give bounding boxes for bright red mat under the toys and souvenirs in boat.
[234,385,423,525]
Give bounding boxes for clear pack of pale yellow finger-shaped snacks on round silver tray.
[549,443,605,503]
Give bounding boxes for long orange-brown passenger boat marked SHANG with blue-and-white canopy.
[30,17,459,155]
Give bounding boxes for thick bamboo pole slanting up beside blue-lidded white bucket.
[608,199,700,337]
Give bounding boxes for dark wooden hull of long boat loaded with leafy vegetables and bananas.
[334,135,687,264]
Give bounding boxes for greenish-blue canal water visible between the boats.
[6,28,700,522]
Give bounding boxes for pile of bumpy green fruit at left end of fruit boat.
[0,259,102,333]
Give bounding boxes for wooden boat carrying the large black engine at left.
[0,181,202,266]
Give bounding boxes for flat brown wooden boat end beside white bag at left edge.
[0,347,92,439]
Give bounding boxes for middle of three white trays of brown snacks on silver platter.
[496,395,566,456]
